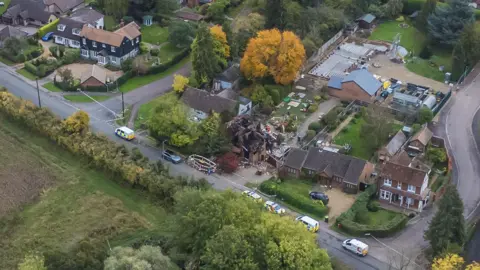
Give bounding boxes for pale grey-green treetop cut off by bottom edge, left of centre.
[104,246,180,270]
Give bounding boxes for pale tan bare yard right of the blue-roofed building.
[369,54,448,93]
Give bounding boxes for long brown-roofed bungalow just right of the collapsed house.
[279,147,375,193]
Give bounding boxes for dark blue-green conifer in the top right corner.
[427,0,475,47]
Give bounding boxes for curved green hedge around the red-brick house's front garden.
[336,185,408,237]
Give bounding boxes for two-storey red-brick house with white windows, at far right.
[378,162,430,212]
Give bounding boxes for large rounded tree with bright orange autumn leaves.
[240,29,305,85]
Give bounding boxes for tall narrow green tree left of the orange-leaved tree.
[192,23,220,83]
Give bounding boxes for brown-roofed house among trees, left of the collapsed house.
[182,87,237,121]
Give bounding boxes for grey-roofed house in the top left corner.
[1,0,57,26]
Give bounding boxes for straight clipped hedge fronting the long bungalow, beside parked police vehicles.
[260,180,329,217]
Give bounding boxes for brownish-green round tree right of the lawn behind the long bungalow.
[360,105,393,152]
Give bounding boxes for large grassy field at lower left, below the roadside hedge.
[0,118,166,269]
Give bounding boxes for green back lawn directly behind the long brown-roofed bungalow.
[333,118,402,160]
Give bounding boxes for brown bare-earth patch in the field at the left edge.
[0,131,55,218]
